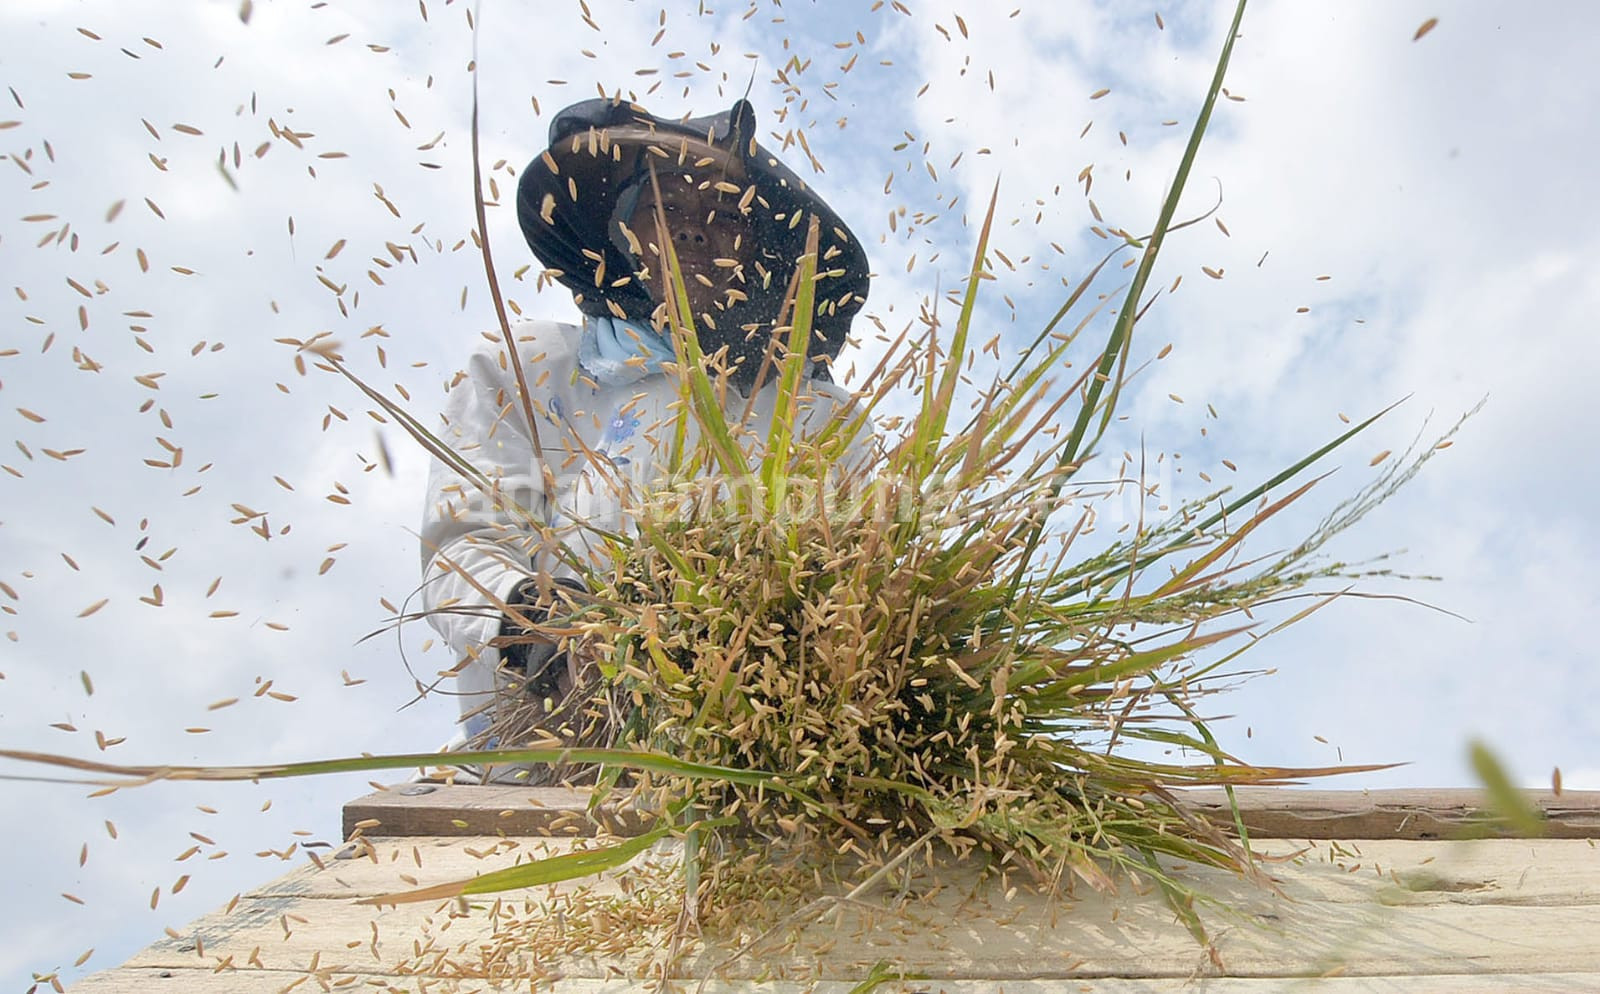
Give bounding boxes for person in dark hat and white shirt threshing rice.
[421,99,869,775]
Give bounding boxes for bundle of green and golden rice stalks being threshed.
[501,176,1440,935]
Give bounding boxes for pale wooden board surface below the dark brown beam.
[78,837,1600,994]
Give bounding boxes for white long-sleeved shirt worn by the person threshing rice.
[422,322,859,738]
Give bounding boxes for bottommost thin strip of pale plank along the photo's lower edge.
[72,968,1600,994]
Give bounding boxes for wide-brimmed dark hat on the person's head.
[517,99,869,368]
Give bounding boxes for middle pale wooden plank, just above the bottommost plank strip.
[118,898,1600,980]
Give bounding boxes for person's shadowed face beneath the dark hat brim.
[629,176,749,325]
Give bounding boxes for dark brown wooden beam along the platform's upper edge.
[344,783,1600,840]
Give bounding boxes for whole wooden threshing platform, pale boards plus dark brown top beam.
[74,783,1600,994]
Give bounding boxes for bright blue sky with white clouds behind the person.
[0,0,1600,989]
